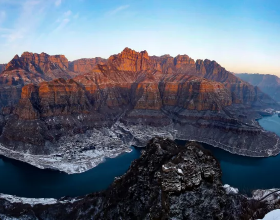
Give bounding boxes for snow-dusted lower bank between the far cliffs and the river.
[0,113,280,174]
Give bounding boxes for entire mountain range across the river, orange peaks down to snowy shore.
[0,48,280,173]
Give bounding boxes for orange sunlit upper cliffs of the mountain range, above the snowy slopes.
[0,48,270,120]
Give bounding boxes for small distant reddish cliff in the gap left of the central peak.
[69,57,107,74]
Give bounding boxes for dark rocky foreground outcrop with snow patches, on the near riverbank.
[0,138,280,220]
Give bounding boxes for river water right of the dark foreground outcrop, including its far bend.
[205,115,280,194]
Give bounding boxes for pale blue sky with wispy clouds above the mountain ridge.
[0,0,280,76]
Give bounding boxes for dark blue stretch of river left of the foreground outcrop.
[0,147,141,198]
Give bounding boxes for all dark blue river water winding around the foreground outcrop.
[0,115,280,198]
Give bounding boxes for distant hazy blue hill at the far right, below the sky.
[236,73,280,102]
